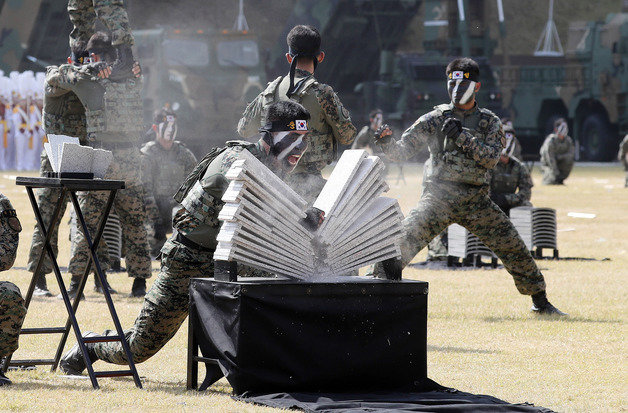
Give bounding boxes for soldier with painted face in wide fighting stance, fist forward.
[374,58,563,314]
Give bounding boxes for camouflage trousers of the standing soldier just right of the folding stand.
[68,148,151,278]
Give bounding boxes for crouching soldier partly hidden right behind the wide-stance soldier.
[489,140,534,215]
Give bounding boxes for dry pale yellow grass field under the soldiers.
[0,165,628,412]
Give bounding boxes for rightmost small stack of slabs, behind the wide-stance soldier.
[510,207,558,251]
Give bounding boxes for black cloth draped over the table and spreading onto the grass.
[190,277,551,413]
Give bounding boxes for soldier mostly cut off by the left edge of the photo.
[0,194,26,386]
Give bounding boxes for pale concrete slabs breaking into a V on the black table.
[214,150,403,279]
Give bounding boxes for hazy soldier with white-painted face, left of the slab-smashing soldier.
[142,110,197,256]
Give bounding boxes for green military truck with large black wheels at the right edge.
[493,13,628,161]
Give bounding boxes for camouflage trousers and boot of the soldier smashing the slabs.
[93,236,214,364]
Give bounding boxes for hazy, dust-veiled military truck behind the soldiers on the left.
[133,28,266,154]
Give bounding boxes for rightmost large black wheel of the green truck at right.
[580,113,616,162]
